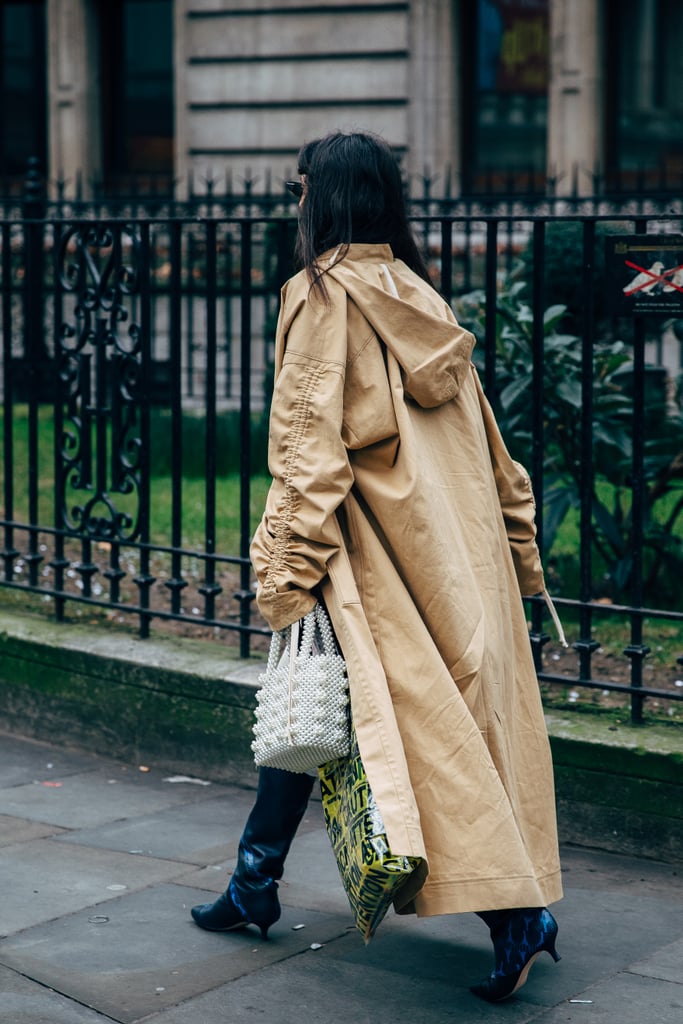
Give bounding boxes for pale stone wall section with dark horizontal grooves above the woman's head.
[175,0,411,190]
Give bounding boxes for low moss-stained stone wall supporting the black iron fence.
[0,610,683,862]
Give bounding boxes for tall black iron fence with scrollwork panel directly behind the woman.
[0,201,683,721]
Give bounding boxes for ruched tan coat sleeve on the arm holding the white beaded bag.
[250,282,353,630]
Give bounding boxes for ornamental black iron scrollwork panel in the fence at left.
[55,222,150,543]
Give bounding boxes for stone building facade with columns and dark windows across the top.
[0,0,683,198]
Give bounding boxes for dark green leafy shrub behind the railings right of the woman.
[456,279,683,603]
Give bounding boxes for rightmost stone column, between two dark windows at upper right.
[548,0,604,195]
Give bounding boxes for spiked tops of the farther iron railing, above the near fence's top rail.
[0,158,683,219]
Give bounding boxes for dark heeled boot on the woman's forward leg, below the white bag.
[191,768,314,939]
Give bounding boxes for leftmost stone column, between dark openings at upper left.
[47,0,101,197]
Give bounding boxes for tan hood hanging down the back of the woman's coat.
[321,244,474,409]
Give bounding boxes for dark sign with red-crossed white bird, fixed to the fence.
[605,234,683,316]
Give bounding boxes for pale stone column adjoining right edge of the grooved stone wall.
[408,0,461,191]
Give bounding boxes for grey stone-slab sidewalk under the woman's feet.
[0,735,683,1024]
